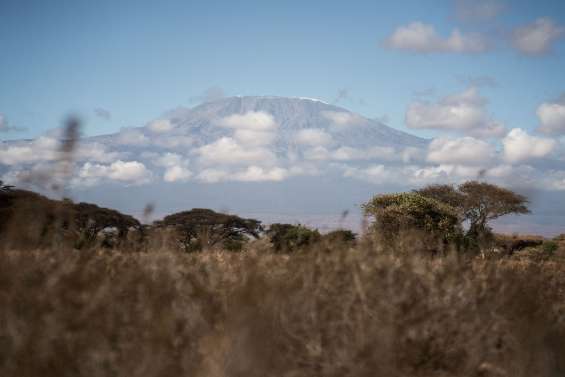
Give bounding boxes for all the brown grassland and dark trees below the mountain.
[0,176,565,377]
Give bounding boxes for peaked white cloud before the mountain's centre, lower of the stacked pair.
[196,137,275,164]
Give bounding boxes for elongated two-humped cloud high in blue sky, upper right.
[384,22,488,53]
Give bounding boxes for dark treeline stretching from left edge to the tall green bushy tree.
[0,182,356,253]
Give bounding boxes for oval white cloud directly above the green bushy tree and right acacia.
[427,136,496,166]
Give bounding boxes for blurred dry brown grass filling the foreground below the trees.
[0,242,565,377]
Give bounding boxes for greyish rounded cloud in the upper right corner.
[512,18,565,55]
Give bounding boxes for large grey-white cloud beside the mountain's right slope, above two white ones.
[406,87,506,137]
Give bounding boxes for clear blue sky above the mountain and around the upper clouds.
[0,0,565,139]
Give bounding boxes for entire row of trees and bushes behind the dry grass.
[0,177,551,255]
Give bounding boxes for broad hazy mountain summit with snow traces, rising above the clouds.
[92,96,427,153]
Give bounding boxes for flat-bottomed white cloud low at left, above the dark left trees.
[73,160,152,186]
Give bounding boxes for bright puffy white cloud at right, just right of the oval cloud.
[502,128,556,163]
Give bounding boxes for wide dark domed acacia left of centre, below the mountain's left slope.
[159,208,263,252]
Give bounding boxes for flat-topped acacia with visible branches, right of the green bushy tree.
[416,181,530,241]
